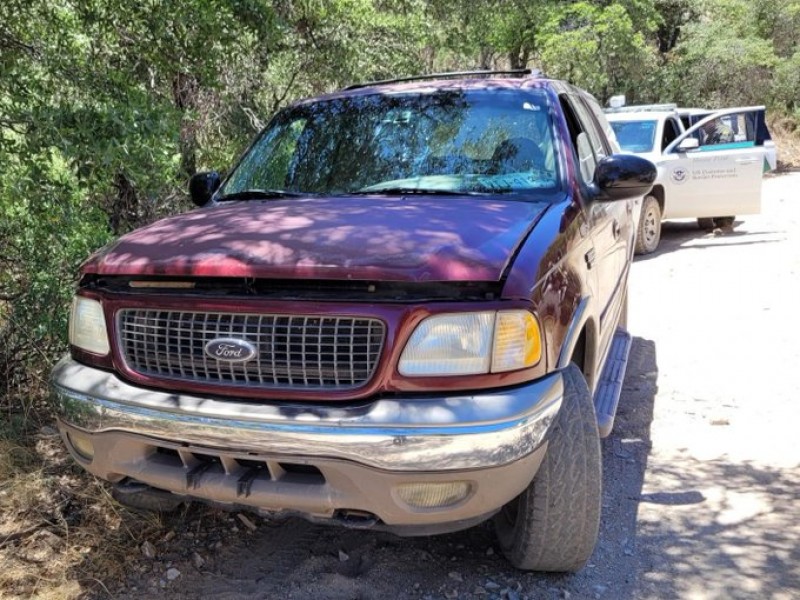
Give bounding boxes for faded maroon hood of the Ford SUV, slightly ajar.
[82,196,547,281]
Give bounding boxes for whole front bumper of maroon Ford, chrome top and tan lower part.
[52,359,563,535]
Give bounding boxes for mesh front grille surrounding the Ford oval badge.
[118,309,385,389]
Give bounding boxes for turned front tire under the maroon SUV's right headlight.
[495,364,602,572]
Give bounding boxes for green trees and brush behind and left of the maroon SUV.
[0,0,800,595]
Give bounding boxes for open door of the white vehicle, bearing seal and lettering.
[659,106,766,218]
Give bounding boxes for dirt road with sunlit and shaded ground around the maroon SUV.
[116,173,800,600]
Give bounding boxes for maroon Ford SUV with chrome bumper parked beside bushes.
[52,72,655,571]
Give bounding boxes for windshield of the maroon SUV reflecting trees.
[218,89,559,200]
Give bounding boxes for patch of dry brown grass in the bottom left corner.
[0,400,162,600]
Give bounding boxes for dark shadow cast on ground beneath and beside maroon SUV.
[111,338,658,600]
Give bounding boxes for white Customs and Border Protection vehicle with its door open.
[606,104,776,254]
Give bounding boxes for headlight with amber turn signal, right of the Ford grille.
[398,310,542,377]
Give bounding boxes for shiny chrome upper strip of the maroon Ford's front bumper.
[51,358,563,472]
